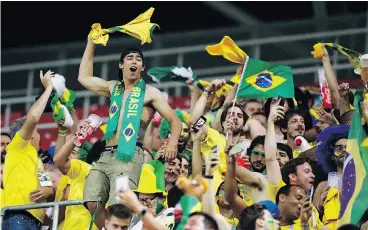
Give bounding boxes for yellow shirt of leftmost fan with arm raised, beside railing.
[3,132,46,223]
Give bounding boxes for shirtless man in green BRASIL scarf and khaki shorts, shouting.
[78,39,181,227]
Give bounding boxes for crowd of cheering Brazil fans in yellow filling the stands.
[1,36,368,230]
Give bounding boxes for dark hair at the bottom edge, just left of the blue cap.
[236,204,266,230]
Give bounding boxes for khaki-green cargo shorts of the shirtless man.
[83,146,144,205]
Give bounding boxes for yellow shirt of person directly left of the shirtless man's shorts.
[63,159,97,230]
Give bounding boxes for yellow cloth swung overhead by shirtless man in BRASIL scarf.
[88,7,160,46]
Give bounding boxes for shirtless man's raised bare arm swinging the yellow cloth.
[78,38,110,97]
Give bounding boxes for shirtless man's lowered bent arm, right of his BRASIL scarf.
[149,87,182,160]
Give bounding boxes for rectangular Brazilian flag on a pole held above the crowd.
[238,57,294,98]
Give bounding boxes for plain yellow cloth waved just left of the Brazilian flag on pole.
[206,36,248,65]
